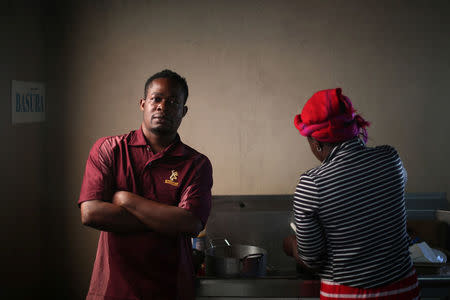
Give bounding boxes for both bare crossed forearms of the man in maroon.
[81,191,203,236]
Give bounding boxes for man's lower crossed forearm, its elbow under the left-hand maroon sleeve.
[81,200,149,233]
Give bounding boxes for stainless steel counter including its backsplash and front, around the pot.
[197,193,450,300]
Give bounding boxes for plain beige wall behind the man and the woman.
[1,1,450,299]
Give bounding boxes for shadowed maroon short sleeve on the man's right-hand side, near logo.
[178,156,213,226]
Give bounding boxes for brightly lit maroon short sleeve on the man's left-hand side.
[78,138,113,205]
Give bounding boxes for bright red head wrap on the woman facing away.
[294,88,369,143]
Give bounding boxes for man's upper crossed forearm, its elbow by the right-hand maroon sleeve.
[113,191,202,236]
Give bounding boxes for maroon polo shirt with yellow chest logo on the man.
[78,129,212,300]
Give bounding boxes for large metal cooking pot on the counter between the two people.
[205,239,267,277]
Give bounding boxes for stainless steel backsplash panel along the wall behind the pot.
[206,193,450,276]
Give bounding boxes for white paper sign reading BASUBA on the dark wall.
[11,80,47,124]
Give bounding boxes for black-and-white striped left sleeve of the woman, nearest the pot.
[294,174,325,268]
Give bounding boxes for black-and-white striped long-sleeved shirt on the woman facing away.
[294,138,412,288]
